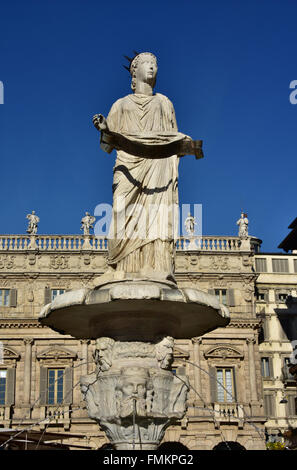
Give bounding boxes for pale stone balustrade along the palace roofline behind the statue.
[0,235,246,252]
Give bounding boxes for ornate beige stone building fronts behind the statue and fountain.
[0,235,297,450]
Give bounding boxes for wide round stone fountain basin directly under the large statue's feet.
[39,282,229,341]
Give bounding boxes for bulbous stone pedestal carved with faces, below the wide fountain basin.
[80,337,189,450]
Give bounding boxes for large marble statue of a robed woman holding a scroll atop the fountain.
[93,52,203,281]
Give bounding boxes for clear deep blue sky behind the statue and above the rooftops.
[0,0,297,251]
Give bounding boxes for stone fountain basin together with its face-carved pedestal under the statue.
[39,279,229,450]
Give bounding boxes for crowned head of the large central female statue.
[129,52,158,91]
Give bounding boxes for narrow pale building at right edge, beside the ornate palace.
[255,253,297,440]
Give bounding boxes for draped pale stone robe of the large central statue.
[107,94,186,277]
